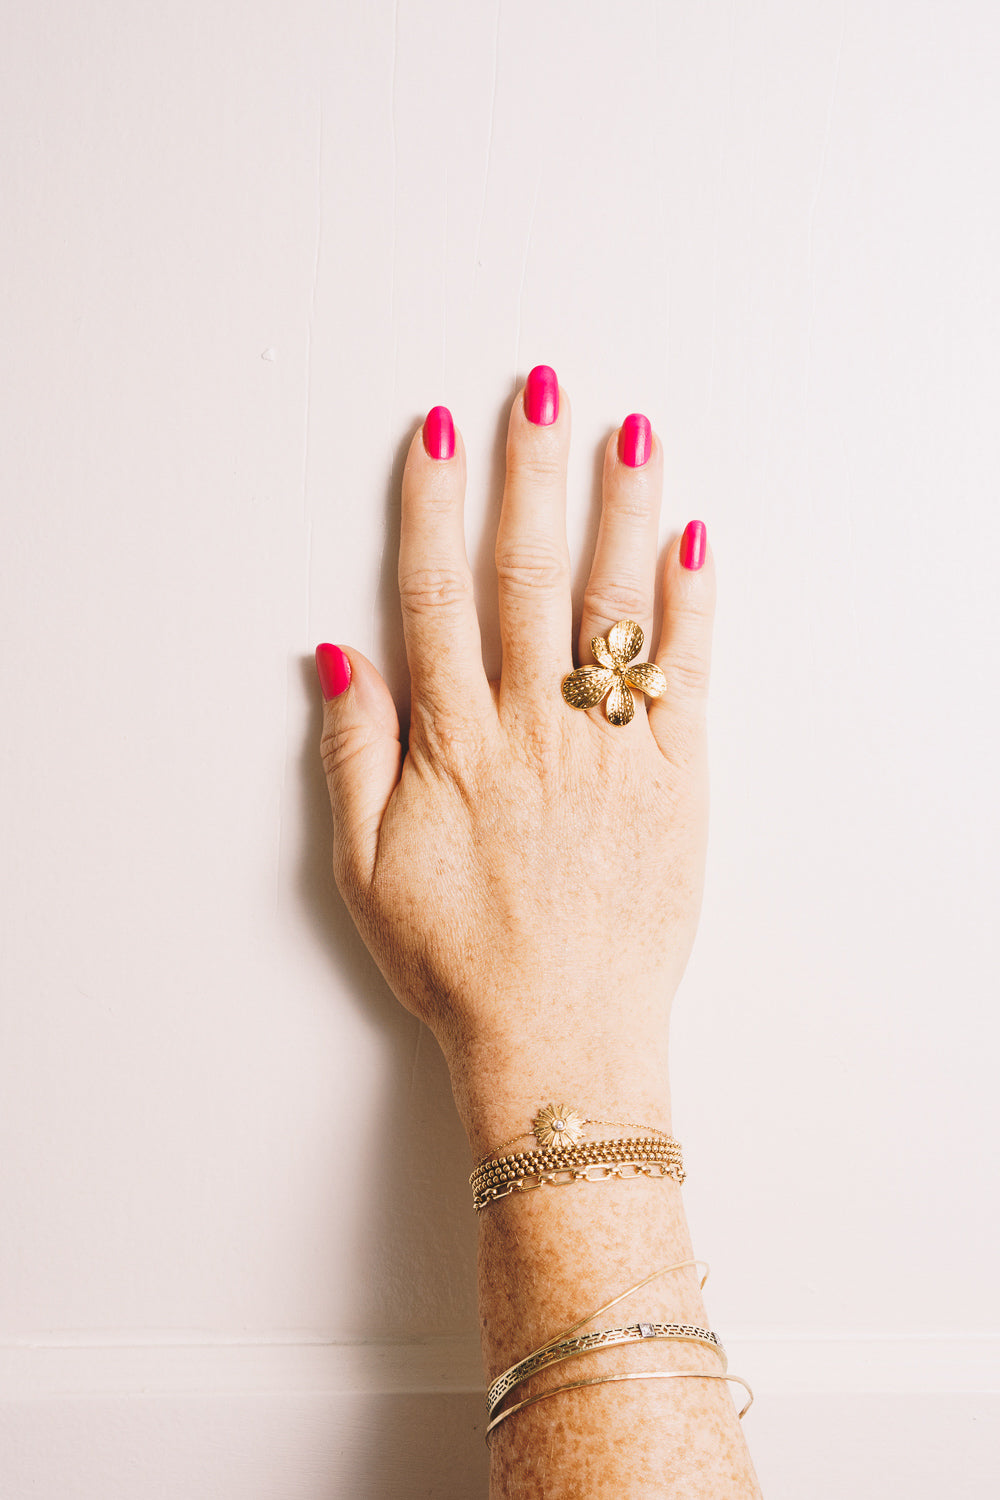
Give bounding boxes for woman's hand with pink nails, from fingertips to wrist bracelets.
[318,366,714,1152]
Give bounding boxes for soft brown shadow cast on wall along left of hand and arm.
[298,423,487,1500]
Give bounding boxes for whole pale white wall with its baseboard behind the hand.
[0,0,1000,1500]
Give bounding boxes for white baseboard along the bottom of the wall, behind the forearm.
[0,1334,1000,1500]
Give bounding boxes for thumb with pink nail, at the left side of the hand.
[316,645,403,890]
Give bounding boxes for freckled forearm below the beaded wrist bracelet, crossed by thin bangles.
[467,1098,760,1500]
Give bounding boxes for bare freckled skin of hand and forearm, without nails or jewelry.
[322,384,760,1500]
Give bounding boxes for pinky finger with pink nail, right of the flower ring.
[648,521,715,761]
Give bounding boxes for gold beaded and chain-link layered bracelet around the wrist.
[469,1137,687,1212]
